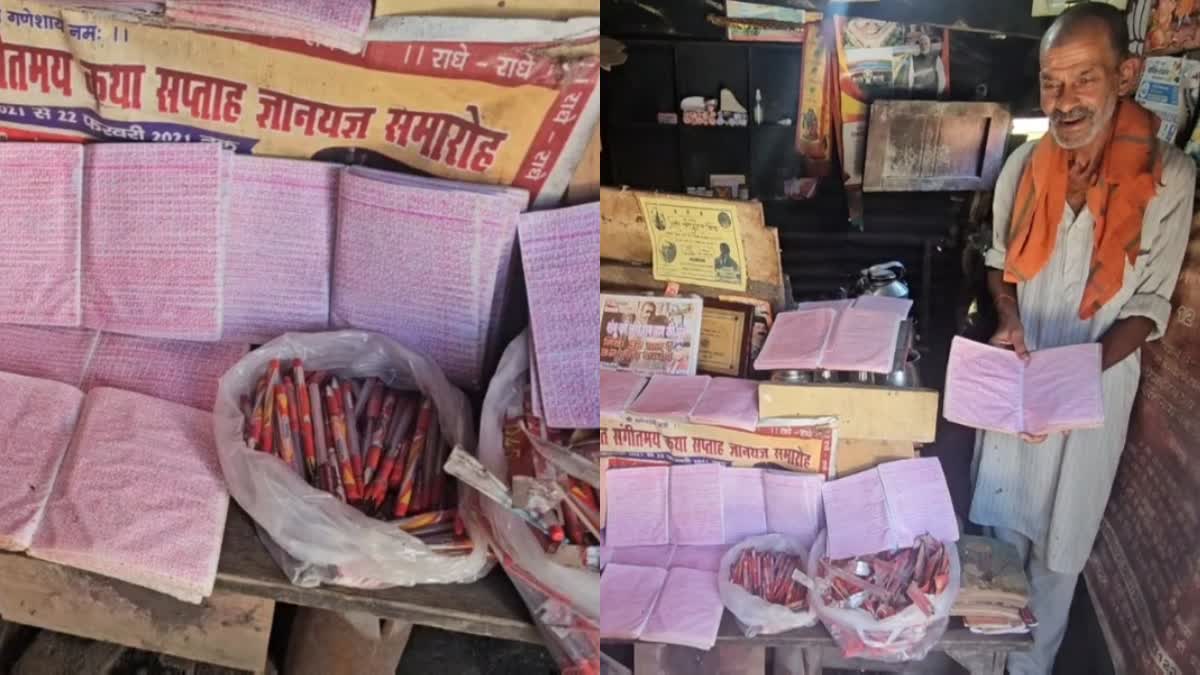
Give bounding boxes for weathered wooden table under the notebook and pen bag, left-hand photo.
[0,504,541,673]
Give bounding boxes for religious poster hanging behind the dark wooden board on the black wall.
[834,17,950,186]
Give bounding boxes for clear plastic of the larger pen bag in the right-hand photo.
[809,530,961,663]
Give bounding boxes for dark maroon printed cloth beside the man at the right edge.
[1085,211,1200,675]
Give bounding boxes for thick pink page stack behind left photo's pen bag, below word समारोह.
[330,168,528,390]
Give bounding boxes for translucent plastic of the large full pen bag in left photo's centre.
[214,330,491,589]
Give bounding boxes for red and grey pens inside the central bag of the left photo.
[242,359,472,555]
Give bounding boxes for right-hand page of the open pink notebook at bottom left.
[29,388,229,603]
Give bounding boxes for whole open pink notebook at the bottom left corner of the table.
[0,374,229,603]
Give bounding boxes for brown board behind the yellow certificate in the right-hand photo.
[600,187,784,310]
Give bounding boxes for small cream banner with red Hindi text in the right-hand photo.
[600,414,836,476]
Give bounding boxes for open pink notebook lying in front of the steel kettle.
[754,297,911,372]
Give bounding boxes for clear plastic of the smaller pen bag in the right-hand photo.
[716,534,817,638]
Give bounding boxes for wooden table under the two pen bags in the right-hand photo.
[606,613,1033,675]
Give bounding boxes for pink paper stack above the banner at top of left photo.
[167,0,372,54]
